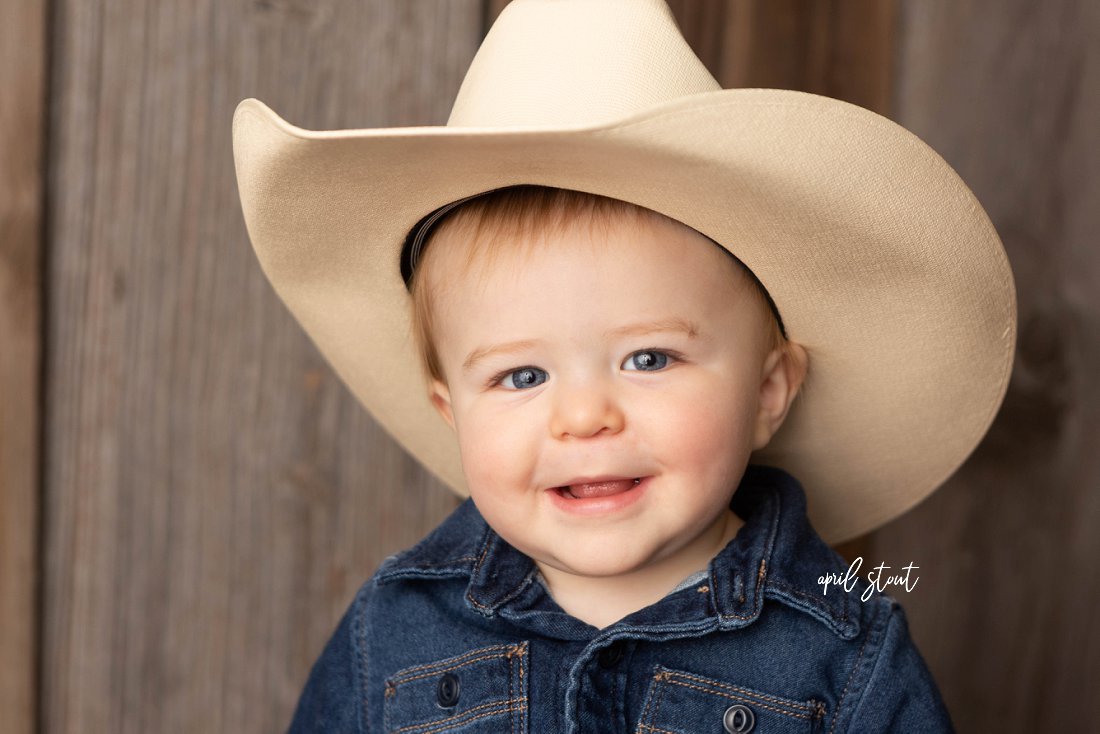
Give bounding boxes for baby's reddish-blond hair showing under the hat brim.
[409,185,789,381]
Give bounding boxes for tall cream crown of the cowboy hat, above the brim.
[447,0,722,128]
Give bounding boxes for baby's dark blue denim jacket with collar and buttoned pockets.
[290,467,954,734]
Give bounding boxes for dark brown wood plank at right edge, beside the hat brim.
[875,0,1100,732]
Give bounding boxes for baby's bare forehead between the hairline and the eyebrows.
[425,209,747,328]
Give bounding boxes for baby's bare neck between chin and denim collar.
[536,510,745,629]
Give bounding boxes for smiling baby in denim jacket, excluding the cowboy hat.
[283,186,952,733]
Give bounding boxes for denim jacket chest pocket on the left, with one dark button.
[383,642,529,734]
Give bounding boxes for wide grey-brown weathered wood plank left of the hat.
[41,0,482,733]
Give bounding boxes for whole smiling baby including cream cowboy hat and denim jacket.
[233,0,1015,734]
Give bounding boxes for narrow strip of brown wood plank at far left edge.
[0,0,46,734]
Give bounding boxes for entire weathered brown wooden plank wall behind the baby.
[0,0,1100,734]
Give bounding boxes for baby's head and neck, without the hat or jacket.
[413,187,806,627]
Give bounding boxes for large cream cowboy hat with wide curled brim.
[233,0,1016,543]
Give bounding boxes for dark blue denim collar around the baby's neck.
[375,465,864,639]
